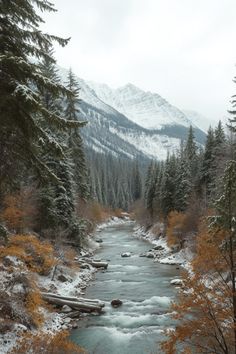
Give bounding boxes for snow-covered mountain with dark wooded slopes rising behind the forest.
[60,69,205,160]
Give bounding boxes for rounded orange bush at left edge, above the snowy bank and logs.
[0,235,55,275]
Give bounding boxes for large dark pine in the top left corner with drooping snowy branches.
[0,0,85,194]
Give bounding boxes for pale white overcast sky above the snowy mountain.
[43,0,236,124]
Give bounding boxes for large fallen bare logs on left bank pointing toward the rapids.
[42,293,105,312]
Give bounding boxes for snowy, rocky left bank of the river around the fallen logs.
[0,217,129,354]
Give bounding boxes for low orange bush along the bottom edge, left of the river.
[9,331,86,354]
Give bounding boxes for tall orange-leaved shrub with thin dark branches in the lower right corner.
[162,221,236,354]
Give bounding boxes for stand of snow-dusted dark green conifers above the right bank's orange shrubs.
[144,122,227,219]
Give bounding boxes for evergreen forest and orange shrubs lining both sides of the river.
[0,0,236,354]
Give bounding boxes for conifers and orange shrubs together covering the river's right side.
[134,120,236,354]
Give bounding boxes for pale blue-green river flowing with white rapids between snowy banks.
[71,222,179,354]
